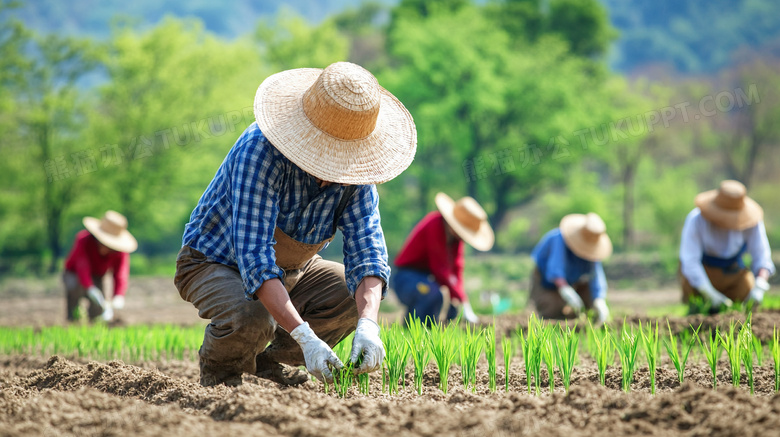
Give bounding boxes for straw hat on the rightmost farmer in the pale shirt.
[695,180,764,231]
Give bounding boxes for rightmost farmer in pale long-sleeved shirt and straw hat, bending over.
[680,180,775,312]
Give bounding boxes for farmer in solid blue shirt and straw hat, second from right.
[530,212,612,324]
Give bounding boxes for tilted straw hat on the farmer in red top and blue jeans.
[435,193,496,252]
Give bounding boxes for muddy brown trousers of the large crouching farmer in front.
[174,246,358,375]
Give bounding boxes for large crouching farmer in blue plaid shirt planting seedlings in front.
[175,62,417,386]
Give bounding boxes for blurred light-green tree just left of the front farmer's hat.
[83,19,267,254]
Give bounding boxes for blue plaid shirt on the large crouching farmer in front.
[182,123,390,300]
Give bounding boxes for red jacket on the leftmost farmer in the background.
[65,229,130,296]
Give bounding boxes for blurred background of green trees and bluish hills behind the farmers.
[0,0,780,290]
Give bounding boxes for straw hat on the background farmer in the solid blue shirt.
[560,212,612,261]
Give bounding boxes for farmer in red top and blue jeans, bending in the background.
[393,193,495,323]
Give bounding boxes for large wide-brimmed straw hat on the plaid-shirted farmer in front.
[254,62,417,185]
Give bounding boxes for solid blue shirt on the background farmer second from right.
[531,228,607,299]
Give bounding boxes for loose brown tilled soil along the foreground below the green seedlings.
[0,350,780,437]
